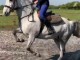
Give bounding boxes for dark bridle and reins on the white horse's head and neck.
[4,0,34,22]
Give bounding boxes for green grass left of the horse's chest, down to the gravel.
[0,16,18,29]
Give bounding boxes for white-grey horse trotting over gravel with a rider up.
[3,0,80,60]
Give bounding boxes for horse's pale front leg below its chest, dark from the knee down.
[27,34,40,56]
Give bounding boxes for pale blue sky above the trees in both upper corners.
[0,0,80,6]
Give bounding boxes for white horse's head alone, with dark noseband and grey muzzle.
[3,0,16,16]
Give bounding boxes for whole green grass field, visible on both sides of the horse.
[0,9,80,28]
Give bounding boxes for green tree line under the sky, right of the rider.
[49,1,80,9]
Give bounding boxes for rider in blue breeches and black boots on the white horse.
[34,0,54,35]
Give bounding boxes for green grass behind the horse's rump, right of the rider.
[52,9,80,20]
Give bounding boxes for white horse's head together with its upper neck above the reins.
[3,0,33,16]
